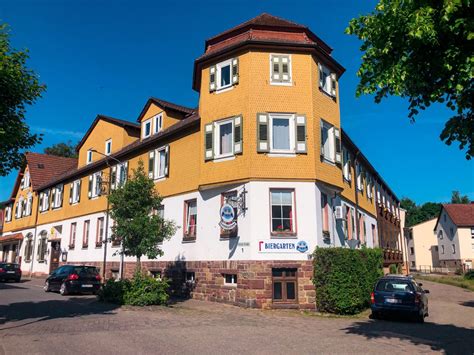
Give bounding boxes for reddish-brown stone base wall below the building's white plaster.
[61,260,316,309]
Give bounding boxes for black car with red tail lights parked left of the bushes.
[44,265,100,296]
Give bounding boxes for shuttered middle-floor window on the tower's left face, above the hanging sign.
[204,116,242,160]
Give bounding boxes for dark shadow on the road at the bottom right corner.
[343,320,474,354]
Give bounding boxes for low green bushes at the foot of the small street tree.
[99,274,169,306]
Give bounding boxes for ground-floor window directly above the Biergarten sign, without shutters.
[270,189,296,234]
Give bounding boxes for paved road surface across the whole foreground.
[0,280,474,355]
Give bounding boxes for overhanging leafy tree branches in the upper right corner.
[346,0,474,159]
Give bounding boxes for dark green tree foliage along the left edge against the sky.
[0,24,45,176]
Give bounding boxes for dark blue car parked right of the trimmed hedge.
[370,275,429,323]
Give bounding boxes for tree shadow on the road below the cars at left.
[0,297,119,331]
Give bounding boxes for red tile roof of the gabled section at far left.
[25,152,77,190]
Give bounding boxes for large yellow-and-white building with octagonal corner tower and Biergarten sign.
[2,14,403,308]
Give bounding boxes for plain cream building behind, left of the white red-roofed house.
[406,218,440,272]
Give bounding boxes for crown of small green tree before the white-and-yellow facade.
[109,160,176,270]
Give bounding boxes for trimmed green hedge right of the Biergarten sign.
[313,248,383,314]
